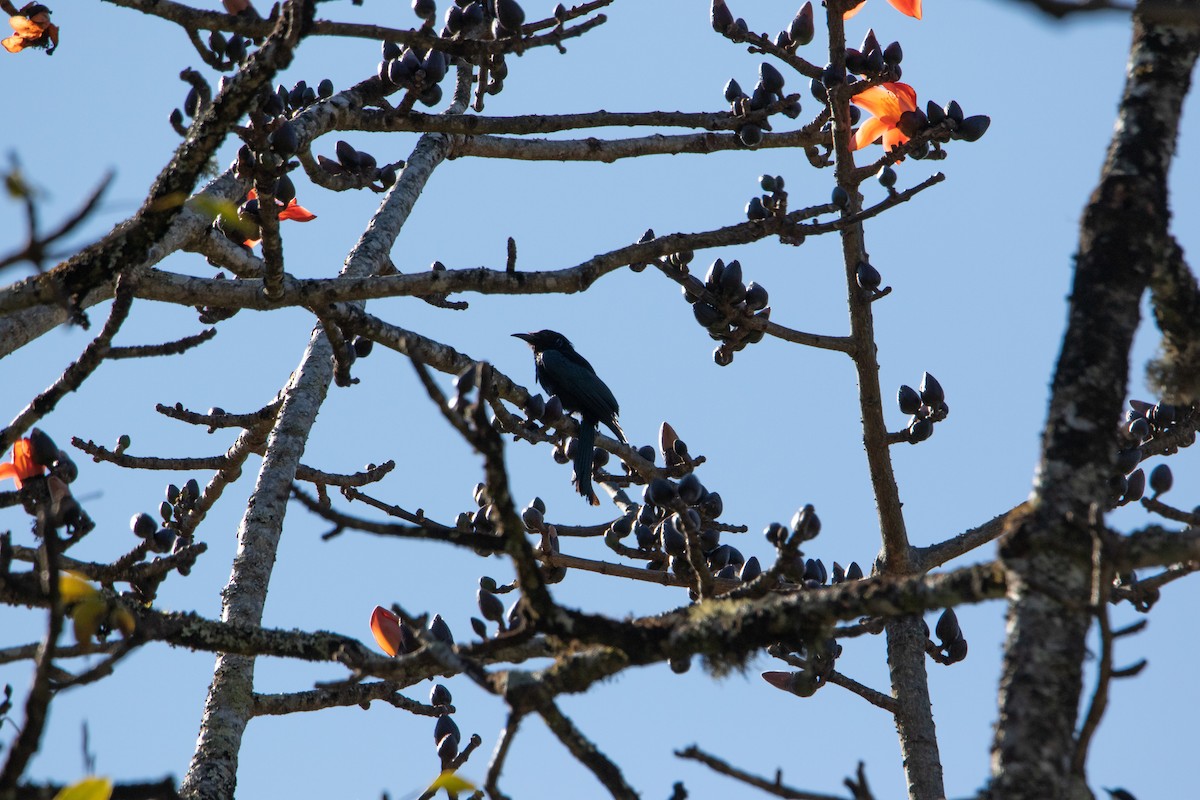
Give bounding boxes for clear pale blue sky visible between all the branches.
[0,0,1200,800]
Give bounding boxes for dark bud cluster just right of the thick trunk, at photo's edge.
[1109,399,1196,506]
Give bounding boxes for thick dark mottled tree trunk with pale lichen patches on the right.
[991,0,1200,800]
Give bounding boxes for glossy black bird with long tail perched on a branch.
[512,331,625,505]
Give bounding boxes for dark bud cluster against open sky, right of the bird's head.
[683,259,770,367]
